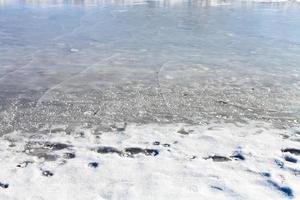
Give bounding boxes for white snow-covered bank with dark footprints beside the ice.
[0,122,300,200]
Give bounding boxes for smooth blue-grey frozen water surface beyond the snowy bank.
[0,1,300,132]
